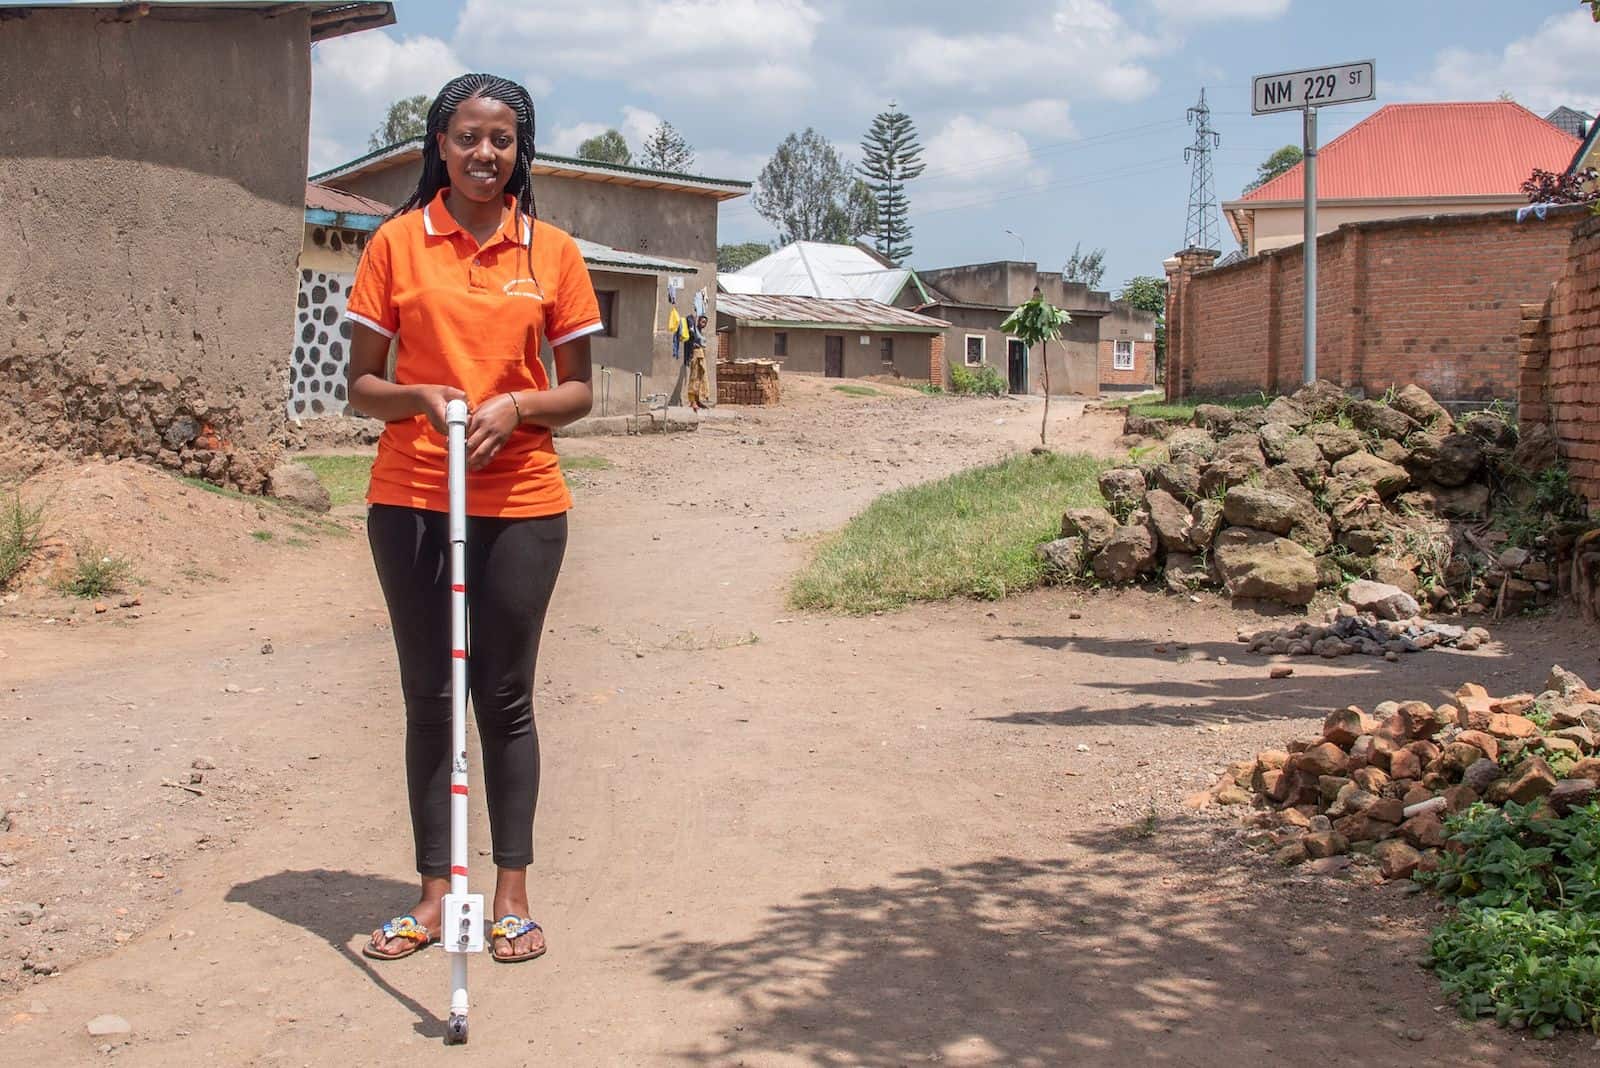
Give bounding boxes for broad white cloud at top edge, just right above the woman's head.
[456,0,822,96]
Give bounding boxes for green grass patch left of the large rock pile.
[790,452,1106,614]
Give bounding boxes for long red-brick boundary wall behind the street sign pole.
[1168,208,1586,401]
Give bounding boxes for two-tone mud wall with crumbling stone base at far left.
[0,8,310,489]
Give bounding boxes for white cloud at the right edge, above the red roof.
[1400,8,1600,115]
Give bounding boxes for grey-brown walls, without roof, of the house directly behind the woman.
[330,161,717,403]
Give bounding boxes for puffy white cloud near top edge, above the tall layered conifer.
[890,0,1174,101]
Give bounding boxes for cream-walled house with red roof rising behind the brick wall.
[1222,101,1579,256]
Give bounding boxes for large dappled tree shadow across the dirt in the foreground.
[627,822,1542,1068]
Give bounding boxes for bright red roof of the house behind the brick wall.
[1237,101,1579,205]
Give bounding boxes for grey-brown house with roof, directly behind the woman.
[323,137,750,412]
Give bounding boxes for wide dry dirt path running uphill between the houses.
[0,384,1595,1066]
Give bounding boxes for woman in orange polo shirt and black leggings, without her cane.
[347,74,602,961]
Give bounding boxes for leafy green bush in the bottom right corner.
[1418,803,1600,1038]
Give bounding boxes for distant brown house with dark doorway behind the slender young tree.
[901,261,1155,397]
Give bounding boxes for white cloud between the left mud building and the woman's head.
[310,30,467,174]
